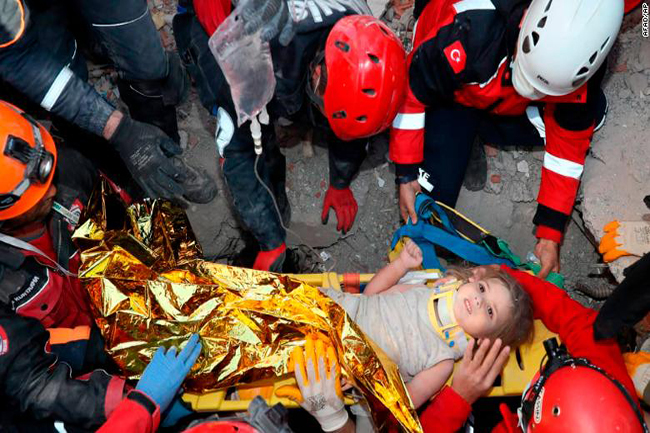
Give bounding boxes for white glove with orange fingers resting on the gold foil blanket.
[275,336,348,432]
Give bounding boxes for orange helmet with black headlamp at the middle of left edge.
[0,101,56,221]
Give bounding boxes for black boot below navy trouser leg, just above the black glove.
[117,53,190,143]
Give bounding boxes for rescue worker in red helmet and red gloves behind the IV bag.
[174,0,405,271]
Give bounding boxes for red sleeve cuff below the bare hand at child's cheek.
[420,385,472,433]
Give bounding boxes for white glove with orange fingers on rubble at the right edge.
[598,220,650,262]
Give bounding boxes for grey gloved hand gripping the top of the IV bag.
[239,0,296,47]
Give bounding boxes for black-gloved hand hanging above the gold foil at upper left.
[109,115,187,202]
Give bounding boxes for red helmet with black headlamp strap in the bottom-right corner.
[521,339,647,433]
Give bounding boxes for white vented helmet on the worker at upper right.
[513,0,624,99]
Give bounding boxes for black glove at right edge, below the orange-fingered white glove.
[594,254,650,340]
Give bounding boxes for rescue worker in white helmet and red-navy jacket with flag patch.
[390,0,624,277]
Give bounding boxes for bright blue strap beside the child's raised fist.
[392,219,515,270]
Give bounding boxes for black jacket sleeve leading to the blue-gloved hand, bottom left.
[0,315,123,429]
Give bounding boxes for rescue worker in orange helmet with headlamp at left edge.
[0,102,97,328]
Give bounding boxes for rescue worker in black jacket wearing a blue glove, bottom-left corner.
[0,305,201,433]
